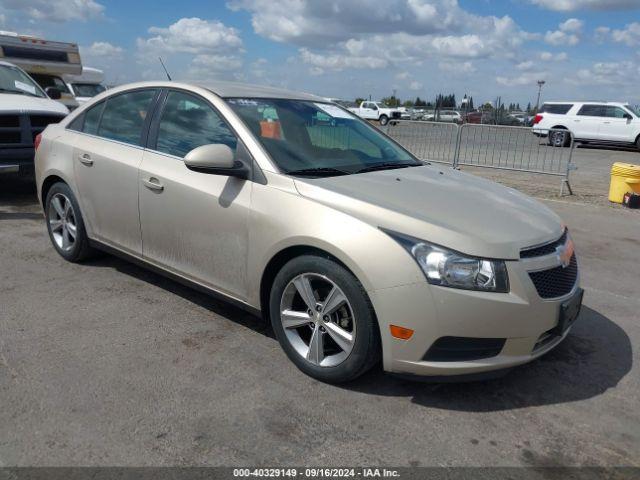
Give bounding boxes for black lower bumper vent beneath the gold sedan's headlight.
[422,337,506,362]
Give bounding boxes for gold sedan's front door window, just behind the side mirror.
[156,91,238,157]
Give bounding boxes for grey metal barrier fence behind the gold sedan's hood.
[386,121,575,195]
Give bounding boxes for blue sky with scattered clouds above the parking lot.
[0,0,640,105]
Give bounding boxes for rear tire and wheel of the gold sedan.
[44,182,95,263]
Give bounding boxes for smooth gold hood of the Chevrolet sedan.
[295,165,564,259]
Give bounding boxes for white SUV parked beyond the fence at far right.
[533,102,640,149]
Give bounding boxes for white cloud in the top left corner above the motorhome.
[2,0,105,22]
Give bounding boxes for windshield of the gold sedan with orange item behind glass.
[227,98,423,176]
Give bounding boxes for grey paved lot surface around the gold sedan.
[0,166,640,466]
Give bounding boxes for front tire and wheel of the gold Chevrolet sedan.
[269,255,381,383]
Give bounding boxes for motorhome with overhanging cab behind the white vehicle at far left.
[0,31,82,110]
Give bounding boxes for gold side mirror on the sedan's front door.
[184,143,249,179]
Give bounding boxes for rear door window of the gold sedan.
[99,90,156,145]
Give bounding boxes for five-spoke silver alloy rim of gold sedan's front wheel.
[280,273,356,367]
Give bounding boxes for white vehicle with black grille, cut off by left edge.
[0,61,69,173]
